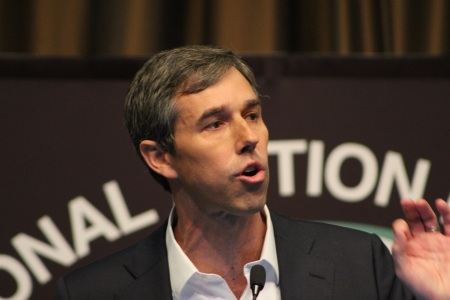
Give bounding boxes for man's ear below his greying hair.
[139,140,178,179]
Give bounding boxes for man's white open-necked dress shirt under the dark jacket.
[166,206,281,300]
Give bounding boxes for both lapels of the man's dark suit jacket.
[114,212,334,300]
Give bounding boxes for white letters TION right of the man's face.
[268,139,431,207]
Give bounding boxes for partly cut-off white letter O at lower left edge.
[0,254,33,300]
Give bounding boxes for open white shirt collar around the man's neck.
[166,205,279,299]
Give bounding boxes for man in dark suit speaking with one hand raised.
[57,46,450,300]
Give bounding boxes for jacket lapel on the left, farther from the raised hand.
[114,222,172,300]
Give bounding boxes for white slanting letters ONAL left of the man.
[0,181,159,300]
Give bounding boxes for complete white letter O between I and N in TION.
[325,143,378,202]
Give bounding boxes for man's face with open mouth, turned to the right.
[169,68,269,215]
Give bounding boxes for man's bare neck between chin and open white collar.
[173,203,266,298]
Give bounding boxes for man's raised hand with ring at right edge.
[392,199,450,299]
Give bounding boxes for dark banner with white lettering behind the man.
[0,55,450,299]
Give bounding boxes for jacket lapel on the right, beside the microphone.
[271,213,334,299]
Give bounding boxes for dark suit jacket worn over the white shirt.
[56,212,412,300]
